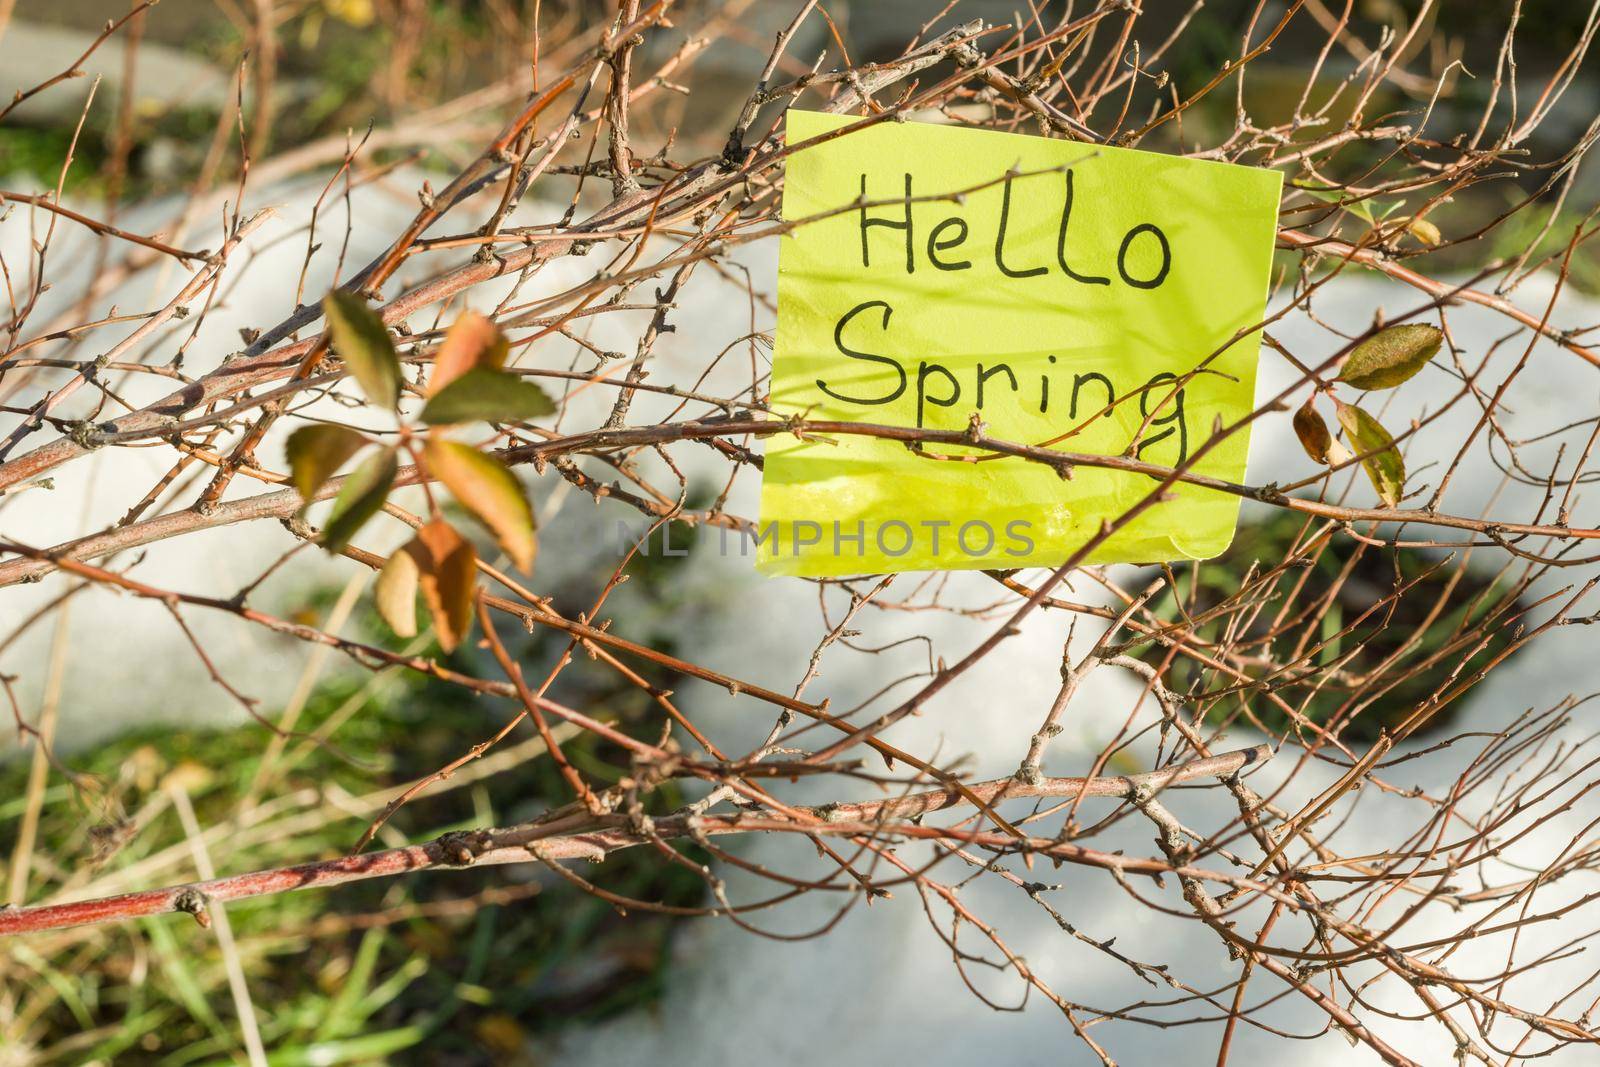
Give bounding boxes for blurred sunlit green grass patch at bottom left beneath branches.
[0,604,704,1067]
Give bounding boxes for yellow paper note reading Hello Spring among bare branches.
[757,110,1282,577]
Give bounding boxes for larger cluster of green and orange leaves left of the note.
[285,290,555,651]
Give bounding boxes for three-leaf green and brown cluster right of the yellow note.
[1294,323,1445,507]
